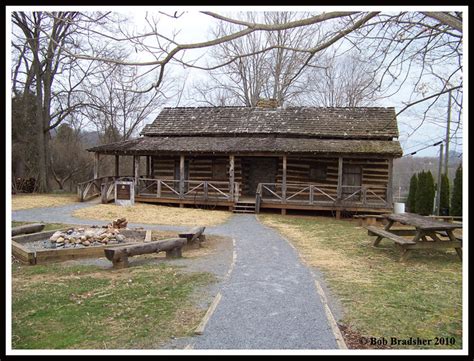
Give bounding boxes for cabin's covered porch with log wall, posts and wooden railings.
[78,153,392,216]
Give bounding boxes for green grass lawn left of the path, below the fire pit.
[12,264,214,349]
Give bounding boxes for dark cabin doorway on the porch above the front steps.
[244,157,278,197]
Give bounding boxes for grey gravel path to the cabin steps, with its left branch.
[12,202,338,350]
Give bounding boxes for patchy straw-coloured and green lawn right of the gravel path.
[259,215,462,349]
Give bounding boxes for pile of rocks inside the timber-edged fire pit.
[49,225,125,248]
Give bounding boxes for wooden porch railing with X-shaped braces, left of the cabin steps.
[136,178,240,202]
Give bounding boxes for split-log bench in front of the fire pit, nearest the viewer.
[104,238,187,268]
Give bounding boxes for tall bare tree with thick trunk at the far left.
[12,11,115,192]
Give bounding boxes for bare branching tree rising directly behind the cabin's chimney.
[191,12,364,106]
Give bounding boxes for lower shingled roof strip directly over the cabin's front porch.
[88,136,403,157]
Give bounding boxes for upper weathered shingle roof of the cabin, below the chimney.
[141,107,398,140]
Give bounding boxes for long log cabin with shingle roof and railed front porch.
[83,100,402,217]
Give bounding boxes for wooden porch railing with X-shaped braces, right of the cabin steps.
[256,183,389,207]
